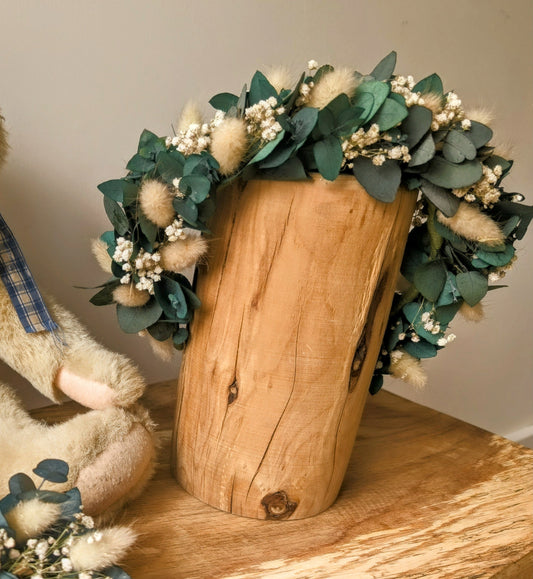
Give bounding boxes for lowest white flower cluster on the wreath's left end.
[113,238,161,295]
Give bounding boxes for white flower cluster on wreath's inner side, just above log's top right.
[341,123,411,169]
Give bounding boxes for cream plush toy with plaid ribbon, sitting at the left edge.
[0,110,155,515]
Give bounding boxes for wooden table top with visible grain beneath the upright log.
[33,382,533,579]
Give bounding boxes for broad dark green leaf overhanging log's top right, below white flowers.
[353,157,402,203]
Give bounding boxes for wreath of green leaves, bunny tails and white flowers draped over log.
[91,52,533,392]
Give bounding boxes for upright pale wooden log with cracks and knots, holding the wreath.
[173,176,416,519]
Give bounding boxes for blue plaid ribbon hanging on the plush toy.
[0,215,58,333]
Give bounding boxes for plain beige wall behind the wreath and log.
[0,0,533,446]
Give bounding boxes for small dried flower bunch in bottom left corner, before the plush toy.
[0,459,135,579]
